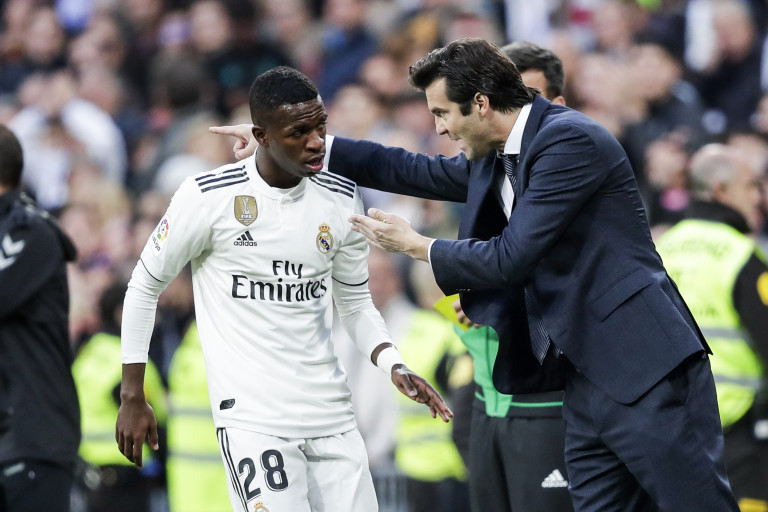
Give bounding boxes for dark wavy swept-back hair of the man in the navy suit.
[410,38,537,116]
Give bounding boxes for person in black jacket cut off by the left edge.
[0,125,80,512]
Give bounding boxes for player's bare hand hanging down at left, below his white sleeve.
[115,398,160,467]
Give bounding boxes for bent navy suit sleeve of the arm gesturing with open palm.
[430,123,626,295]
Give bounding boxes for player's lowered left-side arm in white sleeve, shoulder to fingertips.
[115,179,210,467]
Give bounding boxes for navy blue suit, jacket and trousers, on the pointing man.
[330,97,738,512]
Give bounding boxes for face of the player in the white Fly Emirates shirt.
[263,96,328,182]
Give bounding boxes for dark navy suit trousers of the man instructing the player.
[563,355,739,512]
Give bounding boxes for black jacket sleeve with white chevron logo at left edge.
[0,223,64,320]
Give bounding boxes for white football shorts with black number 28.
[216,428,379,512]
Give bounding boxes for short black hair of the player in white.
[248,66,320,126]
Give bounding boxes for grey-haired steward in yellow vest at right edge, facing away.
[656,144,768,512]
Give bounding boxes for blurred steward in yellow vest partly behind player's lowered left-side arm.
[72,284,167,512]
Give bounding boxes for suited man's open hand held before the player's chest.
[349,208,432,261]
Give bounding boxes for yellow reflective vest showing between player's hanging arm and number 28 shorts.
[166,322,232,512]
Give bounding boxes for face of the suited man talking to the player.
[424,78,494,160]
